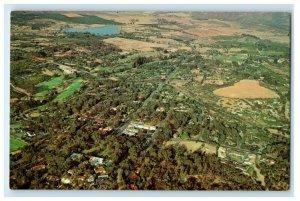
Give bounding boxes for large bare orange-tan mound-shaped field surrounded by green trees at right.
[213,80,279,99]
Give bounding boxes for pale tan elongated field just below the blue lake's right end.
[104,37,168,52]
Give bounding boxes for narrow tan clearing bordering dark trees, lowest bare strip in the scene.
[165,140,217,154]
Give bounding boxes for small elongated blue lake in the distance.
[64,26,120,35]
